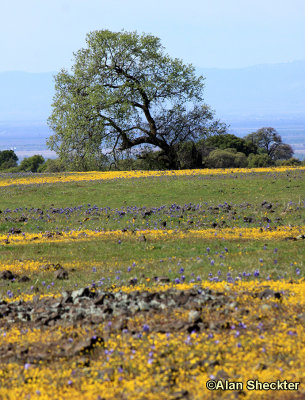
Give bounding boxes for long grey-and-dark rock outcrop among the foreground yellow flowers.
[0,286,228,332]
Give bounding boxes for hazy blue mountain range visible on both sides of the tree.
[0,60,305,155]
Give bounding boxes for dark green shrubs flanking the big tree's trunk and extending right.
[115,134,305,170]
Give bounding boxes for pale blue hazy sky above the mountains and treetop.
[0,0,305,72]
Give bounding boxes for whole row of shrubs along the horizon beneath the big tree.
[0,134,305,172]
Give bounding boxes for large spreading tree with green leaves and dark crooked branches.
[48,30,226,169]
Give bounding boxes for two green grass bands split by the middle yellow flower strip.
[0,170,305,294]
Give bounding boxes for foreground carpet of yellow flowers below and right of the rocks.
[0,280,305,400]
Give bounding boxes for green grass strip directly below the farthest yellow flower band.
[0,170,305,210]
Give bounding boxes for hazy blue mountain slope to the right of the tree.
[197,60,305,123]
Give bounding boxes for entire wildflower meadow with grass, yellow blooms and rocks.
[0,167,305,400]
